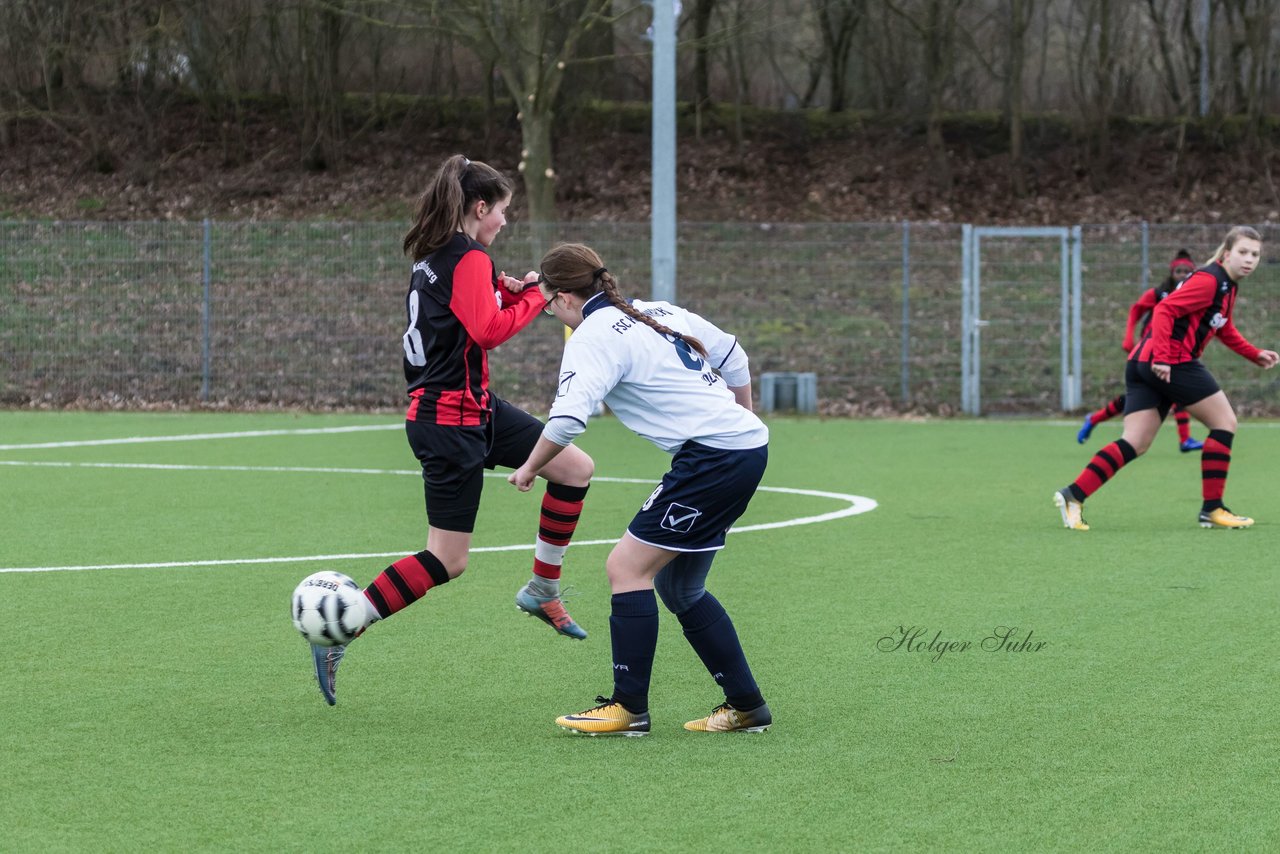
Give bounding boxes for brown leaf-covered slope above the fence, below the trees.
[0,99,1280,224]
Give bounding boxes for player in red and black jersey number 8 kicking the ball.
[311,155,594,705]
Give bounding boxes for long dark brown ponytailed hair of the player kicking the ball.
[404,154,511,261]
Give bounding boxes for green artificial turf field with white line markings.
[0,411,1280,851]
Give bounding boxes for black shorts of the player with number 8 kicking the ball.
[404,394,543,534]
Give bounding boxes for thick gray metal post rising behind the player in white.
[650,0,676,302]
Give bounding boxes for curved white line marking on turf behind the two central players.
[0,460,878,574]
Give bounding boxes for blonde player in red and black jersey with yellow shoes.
[1053,225,1280,530]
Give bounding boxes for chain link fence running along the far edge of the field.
[0,222,1280,415]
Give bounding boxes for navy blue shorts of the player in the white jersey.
[627,442,769,552]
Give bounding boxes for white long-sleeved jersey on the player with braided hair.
[544,293,769,453]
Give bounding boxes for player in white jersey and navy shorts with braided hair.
[508,243,773,735]
